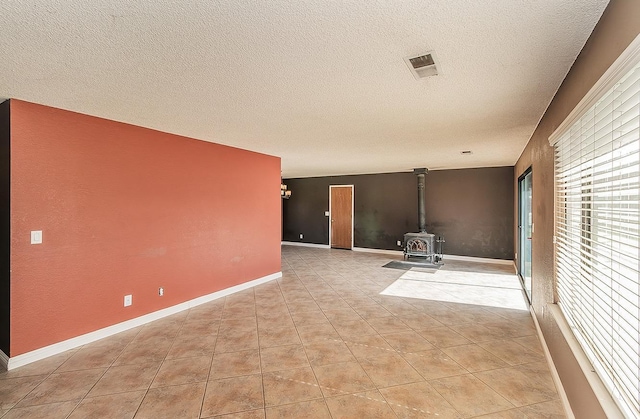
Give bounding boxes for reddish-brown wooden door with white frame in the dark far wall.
[329,186,353,249]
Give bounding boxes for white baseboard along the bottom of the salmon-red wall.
[0,272,282,370]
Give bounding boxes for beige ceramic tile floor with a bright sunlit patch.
[0,246,564,419]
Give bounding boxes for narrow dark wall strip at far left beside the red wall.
[0,100,11,356]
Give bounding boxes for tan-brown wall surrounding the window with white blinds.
[514,0,640,419]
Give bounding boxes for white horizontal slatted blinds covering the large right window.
[555,60,640,418]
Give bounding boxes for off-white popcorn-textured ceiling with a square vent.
[0,0,608,177]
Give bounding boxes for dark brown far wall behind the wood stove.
[283,167,513,259]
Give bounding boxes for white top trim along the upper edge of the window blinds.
[549,35,640,145]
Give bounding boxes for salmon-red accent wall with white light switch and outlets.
[9,99,281,357]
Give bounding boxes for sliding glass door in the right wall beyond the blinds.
[518,169,533,301]
